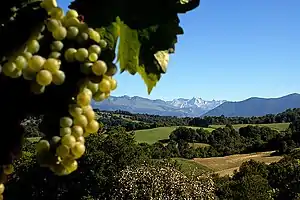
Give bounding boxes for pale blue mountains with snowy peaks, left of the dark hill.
[92,95,225,117]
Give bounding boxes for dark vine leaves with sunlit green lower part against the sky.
[69,0,200,93]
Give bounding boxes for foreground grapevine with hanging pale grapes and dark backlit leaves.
[0,0,200,197]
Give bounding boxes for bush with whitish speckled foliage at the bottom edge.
[112,162,215,200]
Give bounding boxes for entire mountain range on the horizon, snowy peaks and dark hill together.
[92,93,300,117]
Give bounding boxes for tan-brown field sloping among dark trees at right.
[193,151,282,176]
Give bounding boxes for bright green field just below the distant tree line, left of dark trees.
[135,126,214,144]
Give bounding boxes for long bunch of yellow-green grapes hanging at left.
[0,0,117,183]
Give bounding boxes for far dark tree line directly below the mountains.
[96,108,300,131]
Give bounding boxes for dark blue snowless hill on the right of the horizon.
[203,93,300,117]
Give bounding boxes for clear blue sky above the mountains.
[58,0,300,101]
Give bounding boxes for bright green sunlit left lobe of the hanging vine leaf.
[118,20,141,75]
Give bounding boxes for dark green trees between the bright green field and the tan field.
[135,120,300,159]
